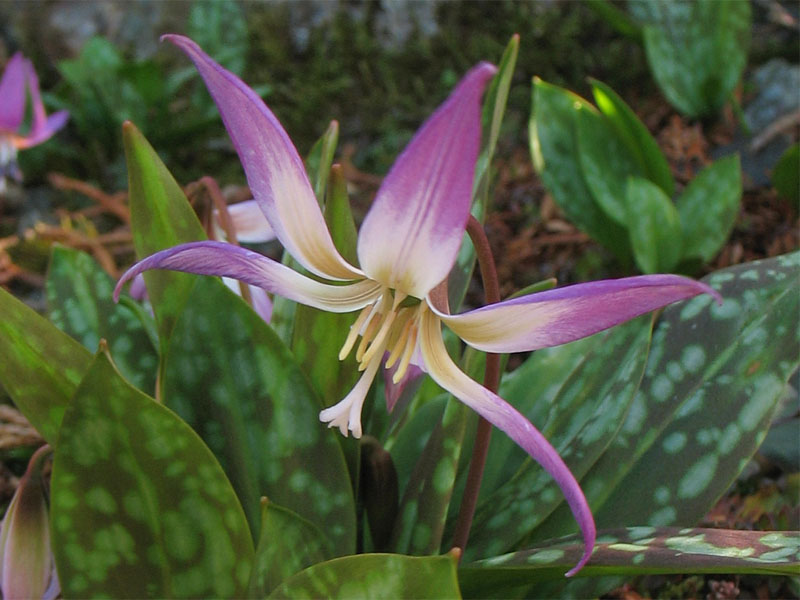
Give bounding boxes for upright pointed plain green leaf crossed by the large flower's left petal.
[122,122,206,364]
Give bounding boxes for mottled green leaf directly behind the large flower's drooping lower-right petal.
[464,315,652,560]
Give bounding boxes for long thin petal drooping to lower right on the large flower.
[419,311,596,576]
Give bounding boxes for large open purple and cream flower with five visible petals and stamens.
[117,35,714,574]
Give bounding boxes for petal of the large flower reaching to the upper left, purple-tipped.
[162,34,362,280]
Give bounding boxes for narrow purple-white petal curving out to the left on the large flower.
[114,242,381,313]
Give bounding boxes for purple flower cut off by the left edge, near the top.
[0,52,69,192]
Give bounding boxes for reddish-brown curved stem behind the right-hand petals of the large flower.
[453,215,500,556]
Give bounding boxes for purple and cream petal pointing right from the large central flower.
[431,275,720,352]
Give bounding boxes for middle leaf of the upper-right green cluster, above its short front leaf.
[575,104,642,227]
